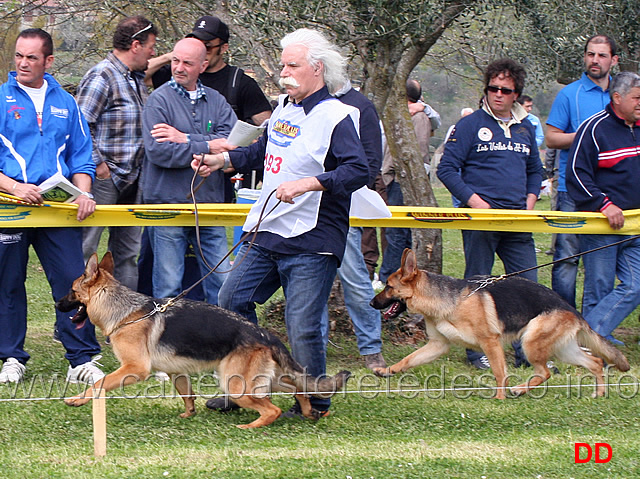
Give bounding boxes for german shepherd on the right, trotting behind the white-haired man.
[371,249,629,399]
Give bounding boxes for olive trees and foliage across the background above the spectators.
[1,0,640,271]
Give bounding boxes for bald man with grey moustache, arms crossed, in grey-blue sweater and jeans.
[141,38,237,304]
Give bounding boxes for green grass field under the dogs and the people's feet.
[0,189,640,479]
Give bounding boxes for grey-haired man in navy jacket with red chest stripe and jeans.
[566,72,640,344]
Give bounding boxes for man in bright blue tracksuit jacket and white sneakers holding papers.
[0,28,104,383]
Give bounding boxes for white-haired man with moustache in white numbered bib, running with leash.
[192,29,368,417]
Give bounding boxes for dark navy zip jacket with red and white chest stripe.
[566,104,640,211]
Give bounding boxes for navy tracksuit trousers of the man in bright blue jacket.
[0,228,100,367]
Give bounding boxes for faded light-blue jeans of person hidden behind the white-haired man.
[322,227,382,355]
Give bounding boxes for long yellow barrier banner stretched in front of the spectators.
[0,193,640,235]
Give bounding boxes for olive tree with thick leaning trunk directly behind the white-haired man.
[205,0,490,271]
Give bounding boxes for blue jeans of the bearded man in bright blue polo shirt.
[551,191,580,308]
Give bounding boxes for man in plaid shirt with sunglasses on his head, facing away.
[77,15,157,289]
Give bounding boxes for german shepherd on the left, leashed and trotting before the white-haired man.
[56,252,350,428]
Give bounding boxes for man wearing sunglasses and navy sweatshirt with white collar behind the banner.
[437,58,543,369]
